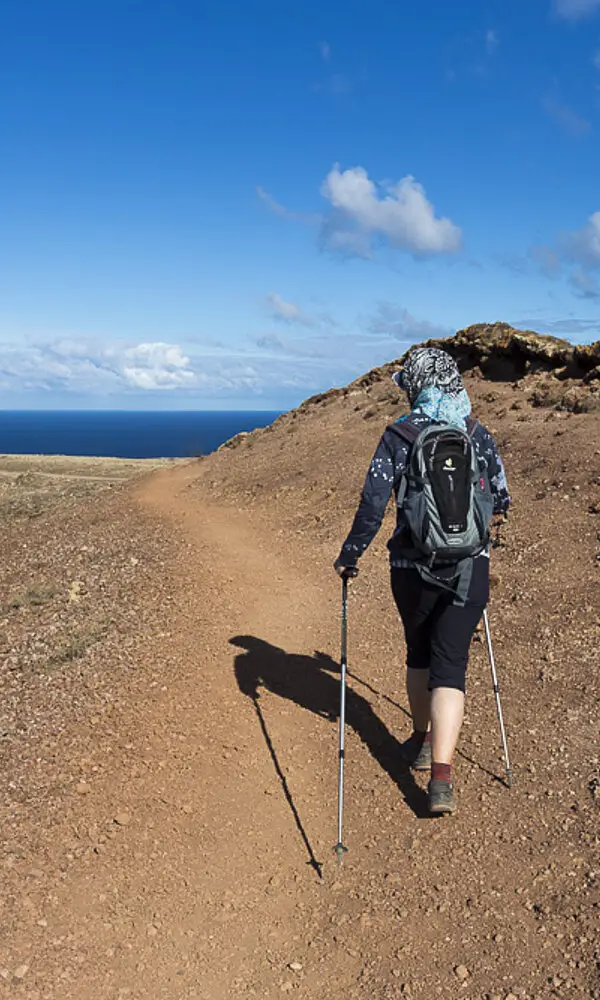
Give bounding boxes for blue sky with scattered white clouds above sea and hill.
[0,0,600,409]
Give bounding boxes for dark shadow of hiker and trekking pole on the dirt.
[229,635,428,875]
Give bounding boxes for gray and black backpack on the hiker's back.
[391,420,494,603]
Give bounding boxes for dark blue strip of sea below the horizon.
[0,410,279,458]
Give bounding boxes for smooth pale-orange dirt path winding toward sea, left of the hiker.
[123,469,370,1000]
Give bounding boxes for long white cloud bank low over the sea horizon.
[0,306,453,409]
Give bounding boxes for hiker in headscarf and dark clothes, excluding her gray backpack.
[334,347,510,814]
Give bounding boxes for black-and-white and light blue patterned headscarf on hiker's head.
[392,347,471,428]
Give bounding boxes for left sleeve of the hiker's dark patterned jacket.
[339,434,408,566]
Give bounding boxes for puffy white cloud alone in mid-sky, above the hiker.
[321,165,461,256]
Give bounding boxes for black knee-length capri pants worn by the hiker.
[392,556,490,691]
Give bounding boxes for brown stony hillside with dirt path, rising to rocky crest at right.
[0,327,600,1000]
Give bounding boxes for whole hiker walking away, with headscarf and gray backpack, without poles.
[334,347,510,814]
